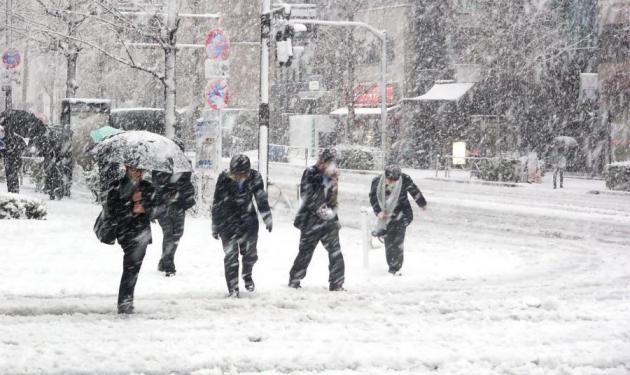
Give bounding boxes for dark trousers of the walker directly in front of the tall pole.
[221,226,258,292]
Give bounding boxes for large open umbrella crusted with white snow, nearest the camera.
[90,130,192,173]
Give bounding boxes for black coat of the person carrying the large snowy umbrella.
[105,176,155,246]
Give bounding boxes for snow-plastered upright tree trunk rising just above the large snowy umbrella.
[164,0,178,139]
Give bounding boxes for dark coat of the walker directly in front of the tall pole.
[212,170,271,236]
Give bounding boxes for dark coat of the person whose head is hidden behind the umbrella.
[152,171,195,216]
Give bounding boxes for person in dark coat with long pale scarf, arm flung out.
[370,165,427,275]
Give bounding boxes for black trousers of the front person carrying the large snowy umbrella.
[118,235,151,307]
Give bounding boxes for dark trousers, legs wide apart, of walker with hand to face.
[289,227,345,287]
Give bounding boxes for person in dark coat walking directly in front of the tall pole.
[212,155,273,298]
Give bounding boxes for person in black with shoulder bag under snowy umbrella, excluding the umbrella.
[105,166,154,314]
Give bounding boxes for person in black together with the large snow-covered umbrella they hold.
[89,131,192,314]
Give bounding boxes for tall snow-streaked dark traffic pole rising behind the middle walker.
[258,0,271,188]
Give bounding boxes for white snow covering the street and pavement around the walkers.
[0,171,630,375]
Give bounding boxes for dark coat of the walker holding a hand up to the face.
[293,166,339,231]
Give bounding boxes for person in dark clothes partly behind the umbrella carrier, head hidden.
[152,171,195,277]
